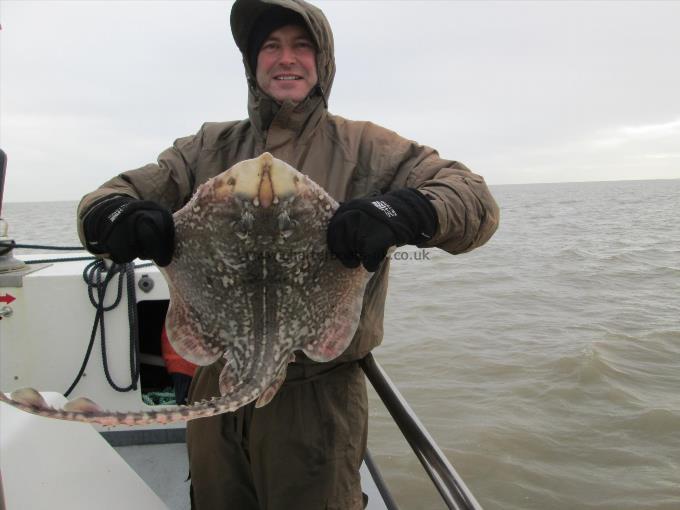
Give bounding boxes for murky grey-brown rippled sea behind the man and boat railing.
[2,180,680,510]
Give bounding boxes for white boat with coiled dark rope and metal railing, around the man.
[0,146,482,510]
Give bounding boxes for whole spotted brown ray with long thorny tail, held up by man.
[0,153,370,426]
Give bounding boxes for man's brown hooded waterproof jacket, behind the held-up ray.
[78,0,499,360]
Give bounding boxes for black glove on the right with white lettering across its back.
[328,188,439,272]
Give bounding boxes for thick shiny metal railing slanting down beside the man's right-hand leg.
[359,354,482,510]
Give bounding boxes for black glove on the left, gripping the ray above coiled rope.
[83,195,175,266]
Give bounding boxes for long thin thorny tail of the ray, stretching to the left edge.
[0,388,257,426]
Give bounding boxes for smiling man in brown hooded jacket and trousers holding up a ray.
[79,0,499,510]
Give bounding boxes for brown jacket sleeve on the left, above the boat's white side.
[77,127,203,246]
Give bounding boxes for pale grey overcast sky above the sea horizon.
[0,0,680,201]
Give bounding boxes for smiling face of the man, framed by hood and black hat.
[256,25,318,103]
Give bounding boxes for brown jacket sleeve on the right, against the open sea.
[362,121,500,254]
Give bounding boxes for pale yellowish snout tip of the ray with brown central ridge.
[218,152,300,208]
